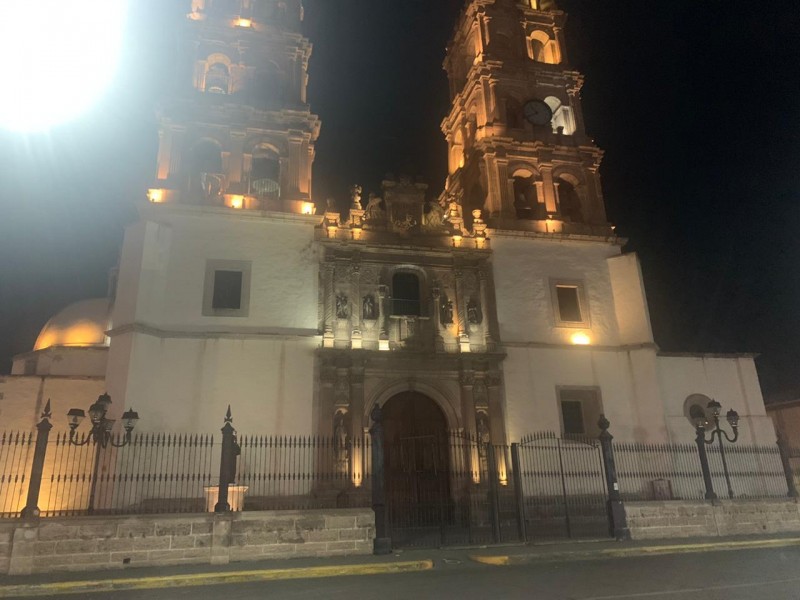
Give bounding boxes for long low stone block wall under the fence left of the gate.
[0,509,375,575]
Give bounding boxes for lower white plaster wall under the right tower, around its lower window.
[503,347,667,443]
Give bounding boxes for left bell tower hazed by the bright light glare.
[148,0,320,214]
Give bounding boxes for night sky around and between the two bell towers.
[0,0,800,403]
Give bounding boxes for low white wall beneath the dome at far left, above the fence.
[0,375,106,432]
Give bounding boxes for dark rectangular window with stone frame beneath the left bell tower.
[203,260,251,317]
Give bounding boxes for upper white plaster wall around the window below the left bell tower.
[113,212,319,332]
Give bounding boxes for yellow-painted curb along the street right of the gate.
[469,538,800,567]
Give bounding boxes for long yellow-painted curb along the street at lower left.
[0,560,433,598]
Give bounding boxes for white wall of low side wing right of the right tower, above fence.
[658,356,775,445]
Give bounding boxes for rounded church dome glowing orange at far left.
[33,298,111,350]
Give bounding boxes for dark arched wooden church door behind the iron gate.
[383,392,452,546]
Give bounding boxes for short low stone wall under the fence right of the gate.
[625,498,800,540]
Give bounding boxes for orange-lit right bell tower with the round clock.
[442,0,610,235]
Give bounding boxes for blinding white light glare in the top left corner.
[0,0,127,131]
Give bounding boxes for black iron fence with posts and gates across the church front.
[0,411,800,546]
